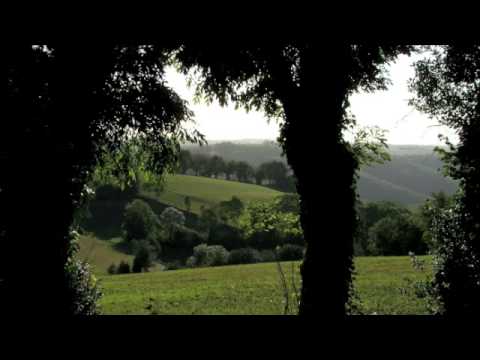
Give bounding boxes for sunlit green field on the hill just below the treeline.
[150,175,283,214]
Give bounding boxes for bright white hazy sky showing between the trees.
[167,55,457,145]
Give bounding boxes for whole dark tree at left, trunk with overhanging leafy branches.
[0,43,202,315]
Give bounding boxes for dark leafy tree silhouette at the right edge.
[411,45,480,315]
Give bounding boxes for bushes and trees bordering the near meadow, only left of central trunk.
[107,190,304,274]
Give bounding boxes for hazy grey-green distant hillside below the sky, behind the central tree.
[185,141,457,205]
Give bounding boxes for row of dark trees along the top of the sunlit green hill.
[178,150,296,192]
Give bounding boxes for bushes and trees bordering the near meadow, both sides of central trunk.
[109,188,446,273]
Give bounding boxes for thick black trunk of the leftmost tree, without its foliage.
[1,45,112,316]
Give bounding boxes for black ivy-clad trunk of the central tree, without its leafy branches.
[282,46,355,317]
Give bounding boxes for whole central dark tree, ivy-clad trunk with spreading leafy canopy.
[178,41,410,316]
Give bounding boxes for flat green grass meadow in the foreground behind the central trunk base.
[100,257,432,315]
